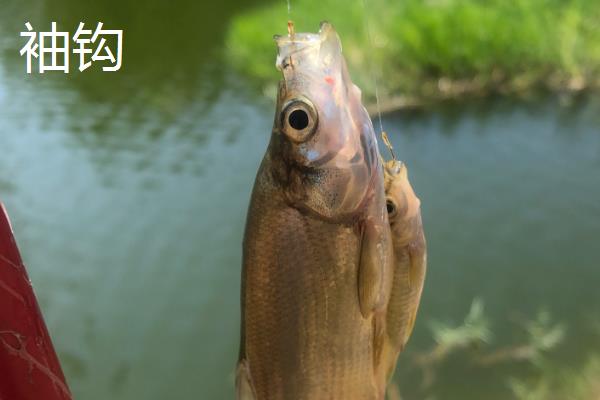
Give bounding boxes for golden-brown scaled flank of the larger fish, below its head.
[246,184,373,399]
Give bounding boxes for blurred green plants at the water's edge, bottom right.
[388,299,600,400]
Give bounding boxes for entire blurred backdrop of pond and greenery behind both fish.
[0,0,600,400]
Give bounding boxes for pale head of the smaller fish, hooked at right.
[384,160,421,242]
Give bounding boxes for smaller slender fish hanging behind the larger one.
[380,159,427,382]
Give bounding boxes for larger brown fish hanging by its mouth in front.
[236,22,394,400]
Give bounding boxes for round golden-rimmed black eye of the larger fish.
[280,98,318,143]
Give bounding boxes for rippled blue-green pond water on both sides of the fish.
[0,0,600,400]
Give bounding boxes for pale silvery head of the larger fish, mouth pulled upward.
[272,22,381,218]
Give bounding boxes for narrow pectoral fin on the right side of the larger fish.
[358,220,393,318]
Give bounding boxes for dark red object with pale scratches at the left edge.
[0,203,71,400]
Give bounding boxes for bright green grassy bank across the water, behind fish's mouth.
[227,0,600,109]
